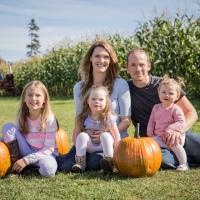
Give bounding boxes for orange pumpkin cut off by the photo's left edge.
[0,142,11,177]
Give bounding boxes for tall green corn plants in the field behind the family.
[14,14,200,97]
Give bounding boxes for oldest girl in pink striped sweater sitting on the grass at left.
[2,80,57,177]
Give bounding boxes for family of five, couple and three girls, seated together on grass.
[1,40,200,177]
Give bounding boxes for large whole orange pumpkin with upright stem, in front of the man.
[113,124,162,177]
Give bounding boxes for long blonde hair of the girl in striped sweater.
[18,80,51,134]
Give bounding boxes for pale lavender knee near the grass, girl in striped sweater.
[39,159,58,177]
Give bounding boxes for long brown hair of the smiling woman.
[79,40,119,96]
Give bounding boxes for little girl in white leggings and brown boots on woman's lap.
[72,86,120,172]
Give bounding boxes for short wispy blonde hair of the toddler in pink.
[158,74,184,97]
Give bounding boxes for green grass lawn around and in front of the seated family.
[0,97,200,200]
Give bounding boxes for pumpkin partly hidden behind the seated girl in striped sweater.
[56,128,69,155]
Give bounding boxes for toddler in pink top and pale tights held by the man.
[147,76,188,171]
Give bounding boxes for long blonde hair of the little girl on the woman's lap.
[78,86,110,131]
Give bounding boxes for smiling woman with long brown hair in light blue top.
[57,40,131,171]
